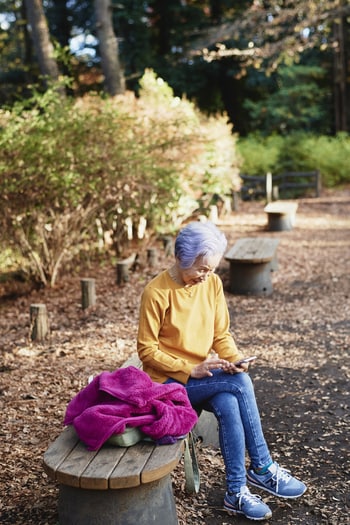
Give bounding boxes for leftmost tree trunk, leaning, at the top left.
[25,0,63,91]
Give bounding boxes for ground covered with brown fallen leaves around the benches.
[0,188,350,525]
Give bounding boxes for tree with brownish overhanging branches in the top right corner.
[187,0,350,131]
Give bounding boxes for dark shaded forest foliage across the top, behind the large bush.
[0,0,350,135]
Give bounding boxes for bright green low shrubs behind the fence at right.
[237,133,350,187]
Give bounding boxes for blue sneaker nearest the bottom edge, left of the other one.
[224,486,272,521]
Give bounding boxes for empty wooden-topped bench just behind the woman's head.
[225,237,279,295]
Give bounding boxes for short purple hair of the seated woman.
[175,221,227,269]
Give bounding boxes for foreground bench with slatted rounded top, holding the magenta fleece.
[43,354,219,525]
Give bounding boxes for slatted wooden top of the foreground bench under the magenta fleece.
[43,427,183,490]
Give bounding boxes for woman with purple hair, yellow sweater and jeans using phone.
[137,222,306,520]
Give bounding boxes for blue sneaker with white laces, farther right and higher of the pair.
[247,462,306,498]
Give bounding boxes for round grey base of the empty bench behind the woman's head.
[230,262,273,295]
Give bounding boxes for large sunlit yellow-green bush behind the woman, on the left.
[0,71,238,285]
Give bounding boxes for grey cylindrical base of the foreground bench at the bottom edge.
[58,474,178,525]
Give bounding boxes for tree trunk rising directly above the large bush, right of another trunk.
[94,0,125,96]
